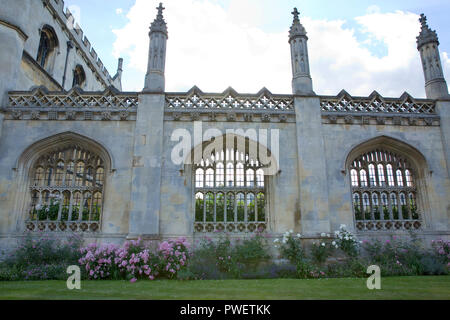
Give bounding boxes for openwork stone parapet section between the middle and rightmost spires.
[320,90,439,126]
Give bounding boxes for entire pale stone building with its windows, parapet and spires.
[0,0,450,250]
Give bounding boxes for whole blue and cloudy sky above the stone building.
[65,0,450,97]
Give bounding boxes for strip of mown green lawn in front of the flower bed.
[0,276,450,300]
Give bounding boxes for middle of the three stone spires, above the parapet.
[289,8,314,95]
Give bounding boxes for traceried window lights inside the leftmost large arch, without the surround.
[27,145,105,232]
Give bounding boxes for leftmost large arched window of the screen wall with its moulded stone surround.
[15,132,112,232]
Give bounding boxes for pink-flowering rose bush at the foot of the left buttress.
[79,238,189,282]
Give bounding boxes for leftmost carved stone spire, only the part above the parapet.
[144,3,168,93]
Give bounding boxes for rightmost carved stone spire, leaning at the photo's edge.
[417,13,448,99]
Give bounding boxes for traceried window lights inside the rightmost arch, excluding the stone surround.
[349,149,422,230]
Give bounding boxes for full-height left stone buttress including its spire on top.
[128,3,167,238]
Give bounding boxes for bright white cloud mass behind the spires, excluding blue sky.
[114,0,450,97]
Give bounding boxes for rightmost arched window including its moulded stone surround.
[345,136,429,231]
